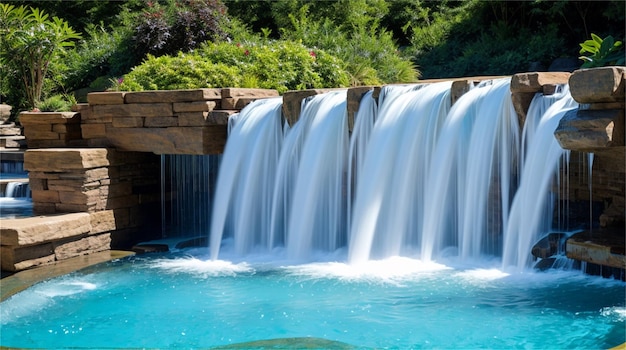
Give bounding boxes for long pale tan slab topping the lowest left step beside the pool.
[0,213,91,246]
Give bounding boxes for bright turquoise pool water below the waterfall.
[0,249,626,349]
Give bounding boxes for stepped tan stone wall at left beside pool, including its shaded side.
[0,148,160,271]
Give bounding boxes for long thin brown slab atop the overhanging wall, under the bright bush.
[124,89,222,104]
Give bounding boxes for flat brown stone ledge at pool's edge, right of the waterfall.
[565,228,626,269]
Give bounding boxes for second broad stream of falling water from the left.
[287,90,348,259]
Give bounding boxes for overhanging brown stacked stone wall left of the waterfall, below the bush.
[76,88,278,155]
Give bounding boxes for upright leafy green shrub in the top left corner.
[0,4,81,108]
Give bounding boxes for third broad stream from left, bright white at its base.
[349,82,451,263]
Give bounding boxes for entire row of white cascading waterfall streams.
[210,78,576,269]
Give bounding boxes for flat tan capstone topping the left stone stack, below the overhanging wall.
[24,148,115,172]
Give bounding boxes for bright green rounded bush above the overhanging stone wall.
[119,41,349,93]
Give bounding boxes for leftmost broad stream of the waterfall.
[210,98,283,259]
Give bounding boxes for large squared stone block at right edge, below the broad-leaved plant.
[569,67,626,103]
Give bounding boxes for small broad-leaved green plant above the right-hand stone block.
[579,33,624,68]
